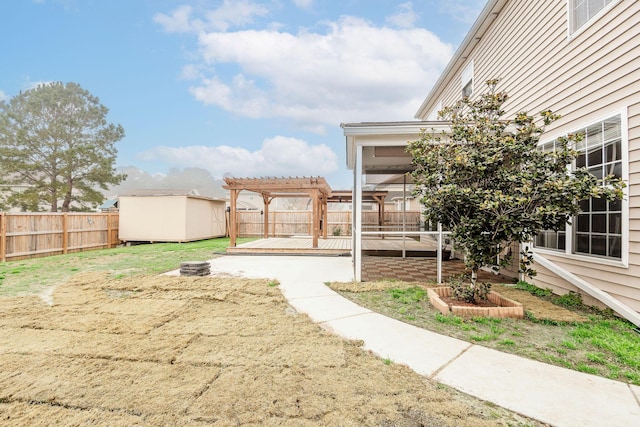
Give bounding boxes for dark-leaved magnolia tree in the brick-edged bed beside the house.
[408,80,624,301]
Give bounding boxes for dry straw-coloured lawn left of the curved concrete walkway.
[0,274,540,426]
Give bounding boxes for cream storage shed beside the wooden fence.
[118,194,226,242]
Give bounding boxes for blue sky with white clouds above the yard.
[0,0,486,189]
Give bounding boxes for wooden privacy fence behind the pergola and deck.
[238,211,421,237]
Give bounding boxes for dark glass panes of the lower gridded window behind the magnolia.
[535,115,626,259]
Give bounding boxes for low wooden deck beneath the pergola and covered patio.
[227,236,444,257]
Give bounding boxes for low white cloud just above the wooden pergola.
[139,136,338,178]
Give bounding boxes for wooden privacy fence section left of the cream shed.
[0,212,118,262]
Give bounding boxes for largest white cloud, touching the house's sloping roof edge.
[185,17,452,130]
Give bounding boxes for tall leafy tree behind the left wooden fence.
[0,82,125,212]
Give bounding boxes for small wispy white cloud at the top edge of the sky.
[153,0,269,33]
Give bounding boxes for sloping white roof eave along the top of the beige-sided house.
[414,0,509,119]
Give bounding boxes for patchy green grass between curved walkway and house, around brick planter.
[336,283,640,385]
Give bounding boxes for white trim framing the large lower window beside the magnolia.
[533,108,630,268]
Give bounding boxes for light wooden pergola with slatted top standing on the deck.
[222,177,331,248]
